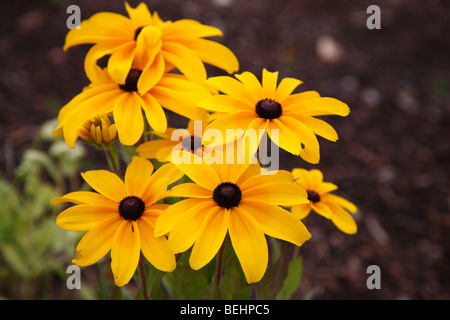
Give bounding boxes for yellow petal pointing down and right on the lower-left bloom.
[137,217,176,272]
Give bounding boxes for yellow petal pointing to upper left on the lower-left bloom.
[81,170,127,203]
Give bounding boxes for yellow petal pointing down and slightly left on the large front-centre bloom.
[189,207,229,270]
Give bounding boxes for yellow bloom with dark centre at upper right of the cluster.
[199,69,350,163]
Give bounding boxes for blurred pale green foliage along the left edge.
[0,119,84,299]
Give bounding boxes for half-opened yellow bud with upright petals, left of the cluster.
[78,113,117,146]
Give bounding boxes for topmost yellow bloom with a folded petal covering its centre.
[64,2,239,83]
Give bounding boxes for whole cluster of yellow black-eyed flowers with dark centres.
[52,3,357,286]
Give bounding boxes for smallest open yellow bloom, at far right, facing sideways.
[291,168,358,234]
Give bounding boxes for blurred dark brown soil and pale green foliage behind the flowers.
[0,0,450,299]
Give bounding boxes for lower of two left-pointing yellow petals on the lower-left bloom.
[56,204,119,231]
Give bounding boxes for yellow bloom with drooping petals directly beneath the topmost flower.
[53,61,211,148]
